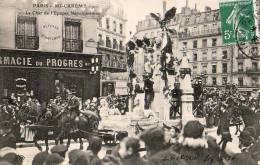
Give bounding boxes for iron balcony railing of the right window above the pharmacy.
[63,39,83,52]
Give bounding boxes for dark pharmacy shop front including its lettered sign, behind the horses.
[0,49,101,102]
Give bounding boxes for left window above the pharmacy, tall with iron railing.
[15,16,38,49]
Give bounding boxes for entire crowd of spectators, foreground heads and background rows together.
[0,85,260,165]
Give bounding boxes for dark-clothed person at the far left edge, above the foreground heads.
[0,121,16,149]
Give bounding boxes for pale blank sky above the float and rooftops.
[113,0,219,36]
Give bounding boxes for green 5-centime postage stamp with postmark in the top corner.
[219,0,256,45]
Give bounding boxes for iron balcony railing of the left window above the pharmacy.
[15,35,39,50]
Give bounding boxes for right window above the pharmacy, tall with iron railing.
[64,19,82,52]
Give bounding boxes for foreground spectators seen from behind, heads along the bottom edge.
[0,116,260,165]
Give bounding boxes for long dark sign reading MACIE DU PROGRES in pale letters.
[0,51,100,70]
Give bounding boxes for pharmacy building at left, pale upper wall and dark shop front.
[0,1,108,102]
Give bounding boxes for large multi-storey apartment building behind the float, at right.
[136,7,260,90]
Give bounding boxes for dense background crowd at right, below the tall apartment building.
[193,85,260,127]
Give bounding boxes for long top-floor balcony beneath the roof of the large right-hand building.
[178,28,221,39]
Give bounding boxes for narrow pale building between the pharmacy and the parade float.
[97,1,127,95]
